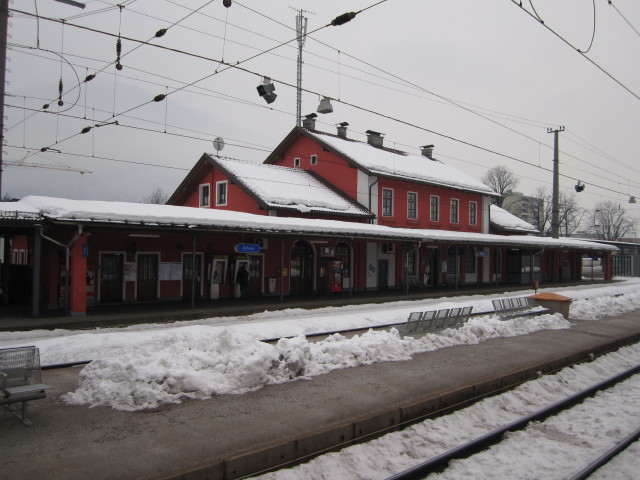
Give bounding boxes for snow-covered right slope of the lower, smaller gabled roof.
[211,156,372,217]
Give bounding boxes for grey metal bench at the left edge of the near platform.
[0,346,51,426]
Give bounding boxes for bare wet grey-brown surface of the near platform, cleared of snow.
[0,311,640,480]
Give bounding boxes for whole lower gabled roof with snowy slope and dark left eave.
[167,153,374,218]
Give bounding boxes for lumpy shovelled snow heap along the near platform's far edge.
[64,314,570,411]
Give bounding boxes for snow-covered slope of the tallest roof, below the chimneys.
[308,132,498,196]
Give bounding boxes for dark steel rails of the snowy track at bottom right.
[387,365,640,480]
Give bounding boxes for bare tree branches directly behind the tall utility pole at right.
[533,187,585,237]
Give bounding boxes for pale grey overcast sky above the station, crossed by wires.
[2,0,640,225]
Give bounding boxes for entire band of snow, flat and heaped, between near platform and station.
[0,279,640,410]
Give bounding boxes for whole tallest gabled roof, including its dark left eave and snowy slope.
[265,127,499,197]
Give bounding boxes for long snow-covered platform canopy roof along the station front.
[10,196,617,251]
